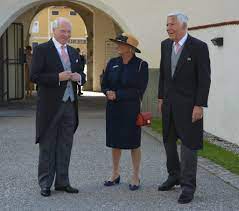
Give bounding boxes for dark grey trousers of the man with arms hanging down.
[164,114,197,194]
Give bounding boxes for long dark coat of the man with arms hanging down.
[158,35,211,149]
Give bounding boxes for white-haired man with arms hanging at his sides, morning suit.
[158,13,211,204]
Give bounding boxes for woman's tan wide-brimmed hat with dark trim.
[110,33,141,53]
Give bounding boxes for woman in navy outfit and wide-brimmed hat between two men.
[101,33,148,190]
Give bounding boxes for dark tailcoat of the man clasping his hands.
[30,40,85,143]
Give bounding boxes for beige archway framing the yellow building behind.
[0,0,127,97]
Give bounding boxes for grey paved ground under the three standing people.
[0,93,239,211]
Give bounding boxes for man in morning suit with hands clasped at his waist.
[31,18,85,196]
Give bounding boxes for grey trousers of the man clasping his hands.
[38,101,76,188]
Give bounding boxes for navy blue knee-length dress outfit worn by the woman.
[101,56,148,149]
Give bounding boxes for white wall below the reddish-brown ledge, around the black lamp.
[190,25,239,144]
